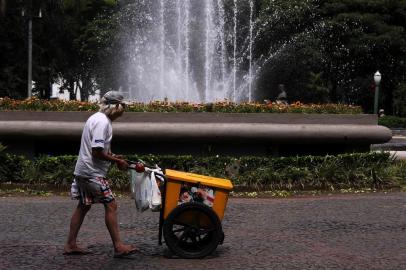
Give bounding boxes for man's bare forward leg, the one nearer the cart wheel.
[104,200,138,254]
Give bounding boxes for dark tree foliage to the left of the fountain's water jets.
[0,0,116,99]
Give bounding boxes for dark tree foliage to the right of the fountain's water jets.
[257,0,406,112]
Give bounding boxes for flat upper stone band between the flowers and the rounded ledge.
[0,111,378,125]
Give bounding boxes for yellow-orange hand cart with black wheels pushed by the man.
[128,161,233,259]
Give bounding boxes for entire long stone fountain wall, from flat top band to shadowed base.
[0,111,392,155]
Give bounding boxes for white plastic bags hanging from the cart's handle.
[129,164,164,212]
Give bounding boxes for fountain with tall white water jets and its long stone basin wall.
[0,0,392,156]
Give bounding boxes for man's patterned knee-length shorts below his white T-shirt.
[71,176,114,205]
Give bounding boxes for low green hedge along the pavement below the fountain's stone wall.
[0,153,406,190]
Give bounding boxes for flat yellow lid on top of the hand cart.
[165,169,233,190]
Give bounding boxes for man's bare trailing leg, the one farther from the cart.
[64,203,91,254]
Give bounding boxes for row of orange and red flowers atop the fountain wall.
[0,97,362,114]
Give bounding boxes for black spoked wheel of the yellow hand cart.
[163,202,224,259]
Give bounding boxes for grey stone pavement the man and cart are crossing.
[0,193,406,270]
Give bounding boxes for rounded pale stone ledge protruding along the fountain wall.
[0,121,392,144]
